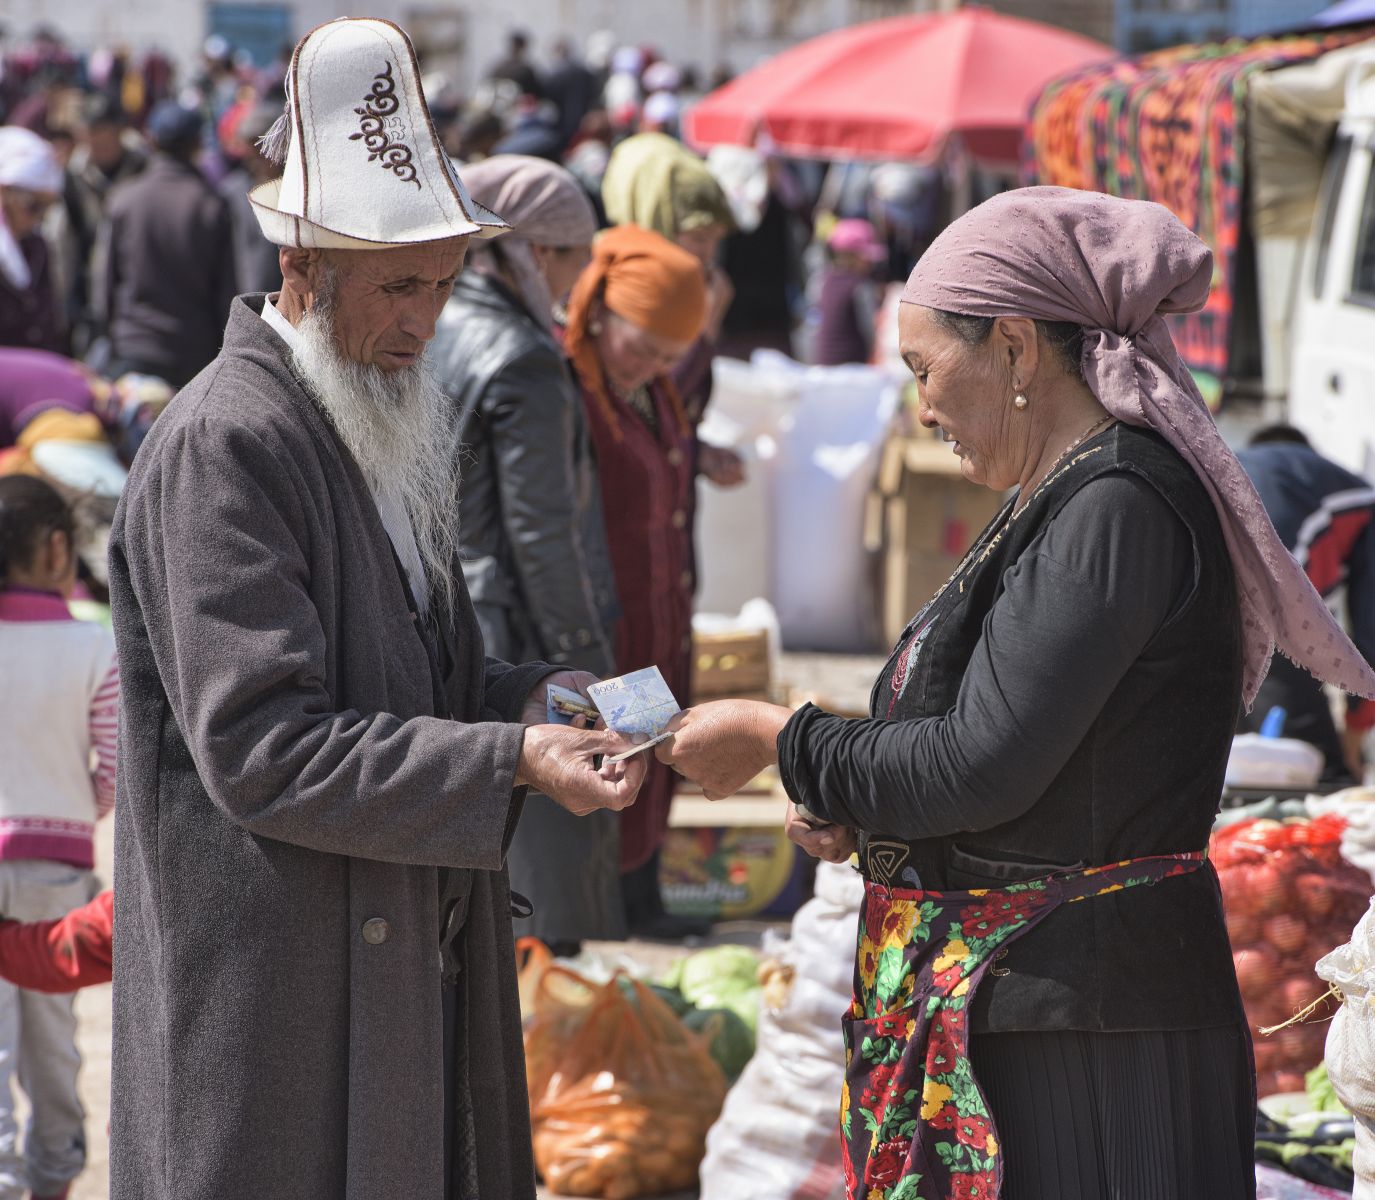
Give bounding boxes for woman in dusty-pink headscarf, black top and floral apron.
[660,188,1375,1200]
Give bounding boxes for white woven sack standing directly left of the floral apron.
[701,863,864,1200]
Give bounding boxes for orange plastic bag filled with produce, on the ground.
[525,966,726,1200]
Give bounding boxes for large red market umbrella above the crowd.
[685,8,1115,164]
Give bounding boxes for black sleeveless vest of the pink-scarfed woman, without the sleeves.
[861,423,1242,1031]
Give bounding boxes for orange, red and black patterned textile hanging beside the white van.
[1023,26,1375,404]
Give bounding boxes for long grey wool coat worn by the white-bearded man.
[110,297,550,1200]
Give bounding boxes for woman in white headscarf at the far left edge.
[0,125,67,355]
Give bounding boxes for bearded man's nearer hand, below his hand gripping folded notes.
[516,720,649,816]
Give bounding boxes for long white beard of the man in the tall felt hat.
[292,304,461,612]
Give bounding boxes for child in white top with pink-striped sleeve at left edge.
[0,476,120,1200]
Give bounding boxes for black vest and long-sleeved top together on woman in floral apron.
[778,425,1242,1030]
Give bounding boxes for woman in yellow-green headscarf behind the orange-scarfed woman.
[602,133,744,487]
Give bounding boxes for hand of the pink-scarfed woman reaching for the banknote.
[655,700,792,800]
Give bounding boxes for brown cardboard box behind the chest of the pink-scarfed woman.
[865,437,1004,646]
